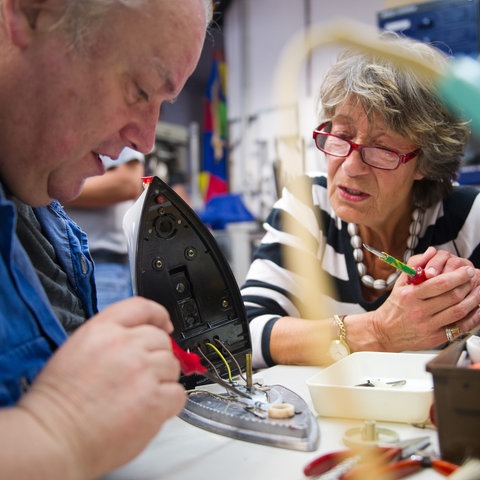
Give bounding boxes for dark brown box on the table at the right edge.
[426,332,480,463]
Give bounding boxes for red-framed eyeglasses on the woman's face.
[313,122,420,170]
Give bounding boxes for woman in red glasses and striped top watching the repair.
[242,38,480,368]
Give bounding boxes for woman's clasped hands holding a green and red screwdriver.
[373,248,480,351]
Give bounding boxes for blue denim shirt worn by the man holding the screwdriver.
[0,185,96,406]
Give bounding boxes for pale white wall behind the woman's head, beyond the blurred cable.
[224,0,410,218]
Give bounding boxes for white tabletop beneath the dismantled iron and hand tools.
[103,365,445,480]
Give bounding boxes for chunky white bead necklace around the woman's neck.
[347,208,423,290]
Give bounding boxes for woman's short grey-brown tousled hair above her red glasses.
[319,31,470,208]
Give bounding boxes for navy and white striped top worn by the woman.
[241,175,480,368]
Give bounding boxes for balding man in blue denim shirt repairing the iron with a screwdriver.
[0,0,211,480]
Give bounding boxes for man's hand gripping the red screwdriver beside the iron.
[19,297,186,478]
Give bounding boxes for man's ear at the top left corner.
[2,0,38,48]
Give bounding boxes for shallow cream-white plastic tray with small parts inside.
[307,352,435,423]
